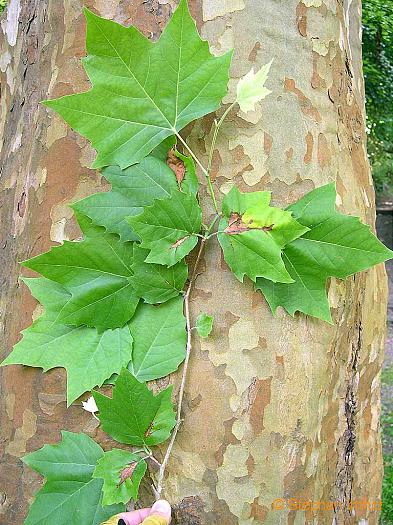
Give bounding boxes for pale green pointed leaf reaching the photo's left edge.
[1,278,132,404]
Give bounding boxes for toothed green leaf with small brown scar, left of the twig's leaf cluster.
[128,191,202,266]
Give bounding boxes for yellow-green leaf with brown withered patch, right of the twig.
[218,185,308,283]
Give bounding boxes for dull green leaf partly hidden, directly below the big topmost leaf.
[72,156,177,241]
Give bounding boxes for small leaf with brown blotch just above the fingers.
[93,448,147,505]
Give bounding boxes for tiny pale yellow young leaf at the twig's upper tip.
[236,60,273,113]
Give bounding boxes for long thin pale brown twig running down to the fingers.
[155,237,207,499]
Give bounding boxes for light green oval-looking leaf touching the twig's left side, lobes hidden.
[128,297,187,381]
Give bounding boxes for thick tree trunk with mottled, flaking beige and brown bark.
[0,0,387,525]
